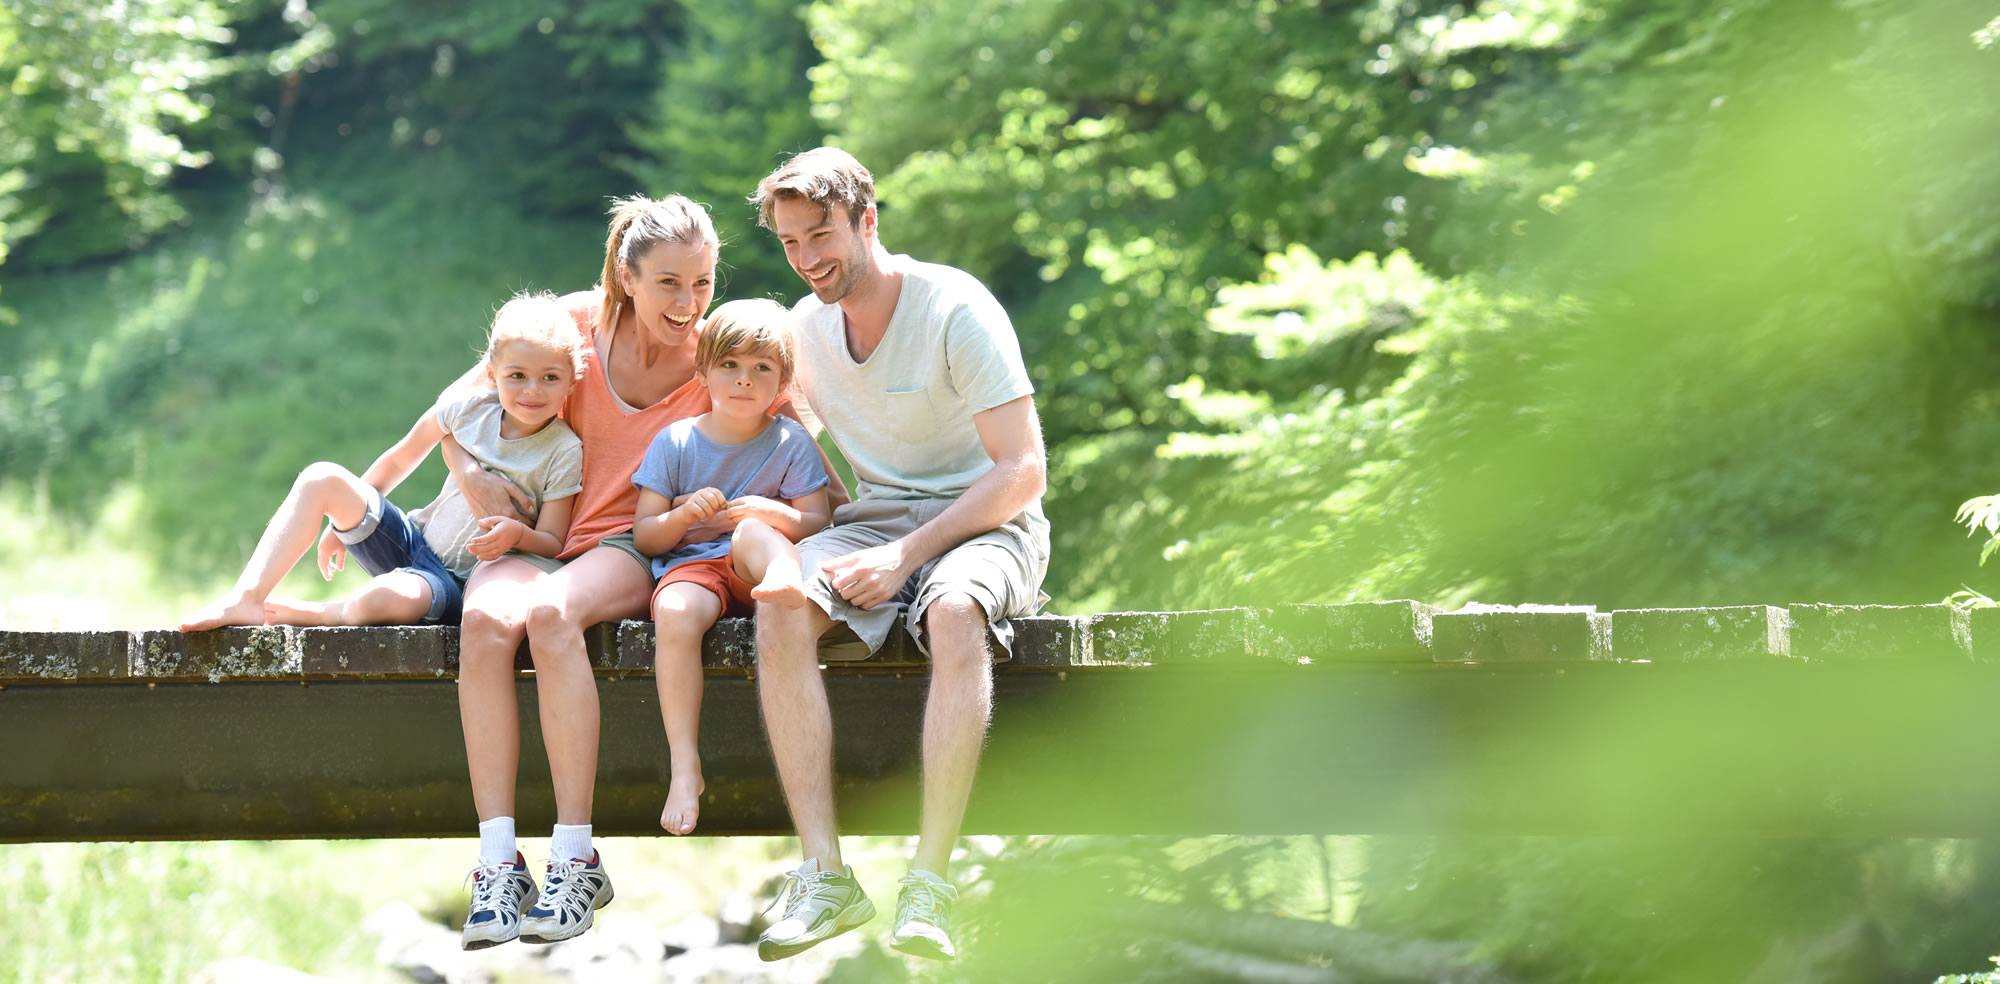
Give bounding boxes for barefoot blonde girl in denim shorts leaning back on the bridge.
[180,294,582,632]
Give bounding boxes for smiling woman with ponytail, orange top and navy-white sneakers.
[444,196,824,950]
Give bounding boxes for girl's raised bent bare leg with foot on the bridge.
[180,462,376,632]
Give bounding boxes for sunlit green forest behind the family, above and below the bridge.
[0,0,2000,980]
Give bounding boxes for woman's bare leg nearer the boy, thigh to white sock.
[528,546,652,824]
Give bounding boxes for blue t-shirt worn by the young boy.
[632,416,826,578]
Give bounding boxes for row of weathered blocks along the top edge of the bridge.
[0,600,2000,686]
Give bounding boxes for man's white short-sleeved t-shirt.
[792,256,1048,536]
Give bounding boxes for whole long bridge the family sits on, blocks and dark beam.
[0,602,2000,842]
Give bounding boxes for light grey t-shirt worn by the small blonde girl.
[410,390,584,578]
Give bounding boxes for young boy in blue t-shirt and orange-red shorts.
[632,300,832,834]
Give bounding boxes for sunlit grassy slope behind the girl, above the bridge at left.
[0,148,602,628]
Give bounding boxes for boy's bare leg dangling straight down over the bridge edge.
[652,582,722,834]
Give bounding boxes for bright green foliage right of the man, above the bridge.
[816,2,2000,608]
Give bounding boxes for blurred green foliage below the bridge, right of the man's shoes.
[918,836,2000,984]
